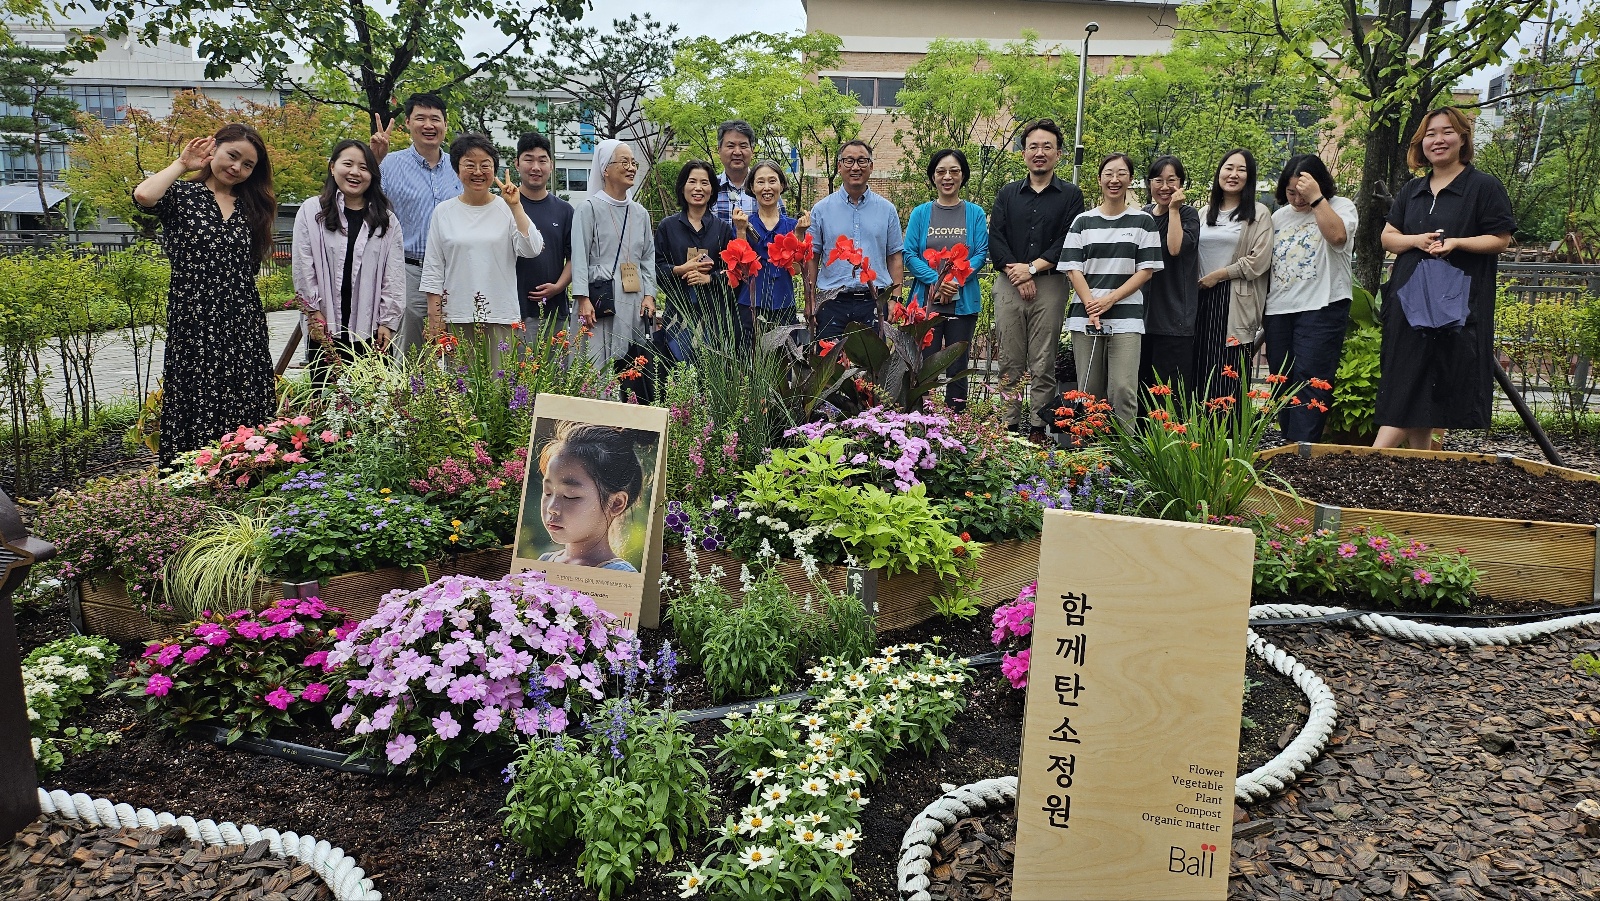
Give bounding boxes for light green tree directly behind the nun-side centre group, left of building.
[645,32,861,203]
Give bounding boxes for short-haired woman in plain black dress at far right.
[1373,109,1517,450]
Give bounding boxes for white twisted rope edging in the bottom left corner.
[38,789,382,901]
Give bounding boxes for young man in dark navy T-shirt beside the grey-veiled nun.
[517,131,573,334]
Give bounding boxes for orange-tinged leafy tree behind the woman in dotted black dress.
[62,91,350,237]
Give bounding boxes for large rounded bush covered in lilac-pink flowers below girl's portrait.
[330,573,645,771]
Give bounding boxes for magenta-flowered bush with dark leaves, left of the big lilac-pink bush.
[112,597,355,743]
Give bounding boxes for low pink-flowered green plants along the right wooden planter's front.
[1254,520,1483,607]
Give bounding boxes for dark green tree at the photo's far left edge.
[0,30,106,227]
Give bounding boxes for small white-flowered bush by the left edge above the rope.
[22,635,117,776]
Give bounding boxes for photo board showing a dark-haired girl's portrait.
[512,394,667,629]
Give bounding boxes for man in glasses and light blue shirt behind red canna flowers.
[805,141,904,341]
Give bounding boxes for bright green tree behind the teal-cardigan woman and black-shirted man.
[894,32,1078,203]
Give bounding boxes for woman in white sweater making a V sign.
[421,134,544,366]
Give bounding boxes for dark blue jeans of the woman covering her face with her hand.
[1266,298,1350,442]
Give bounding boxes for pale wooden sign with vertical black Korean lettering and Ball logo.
[1011,511,1254,901]
